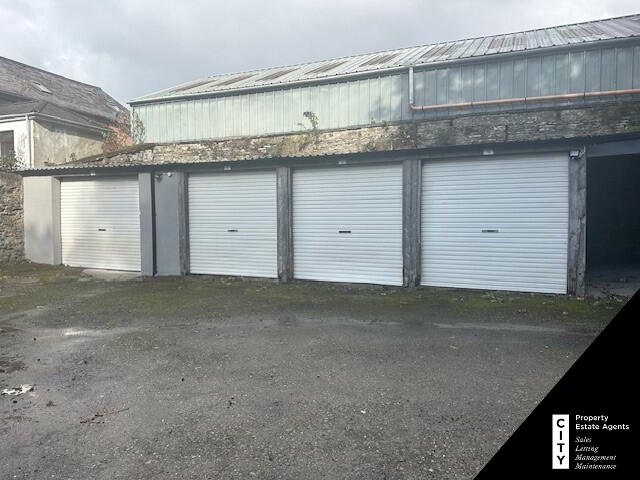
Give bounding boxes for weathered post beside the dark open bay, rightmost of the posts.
[567,149,587,297]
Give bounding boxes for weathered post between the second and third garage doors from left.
[276,167,294,282]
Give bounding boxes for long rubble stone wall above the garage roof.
[63,102,640,167]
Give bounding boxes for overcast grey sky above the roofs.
[0,0,640,103]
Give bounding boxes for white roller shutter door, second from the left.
[188,170,278,278]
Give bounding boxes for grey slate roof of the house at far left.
[0,57,126,125]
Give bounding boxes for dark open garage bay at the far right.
[586,155,640,296]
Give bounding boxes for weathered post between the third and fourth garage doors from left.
[402,159,422,287]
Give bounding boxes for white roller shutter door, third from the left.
[293,164,402,285]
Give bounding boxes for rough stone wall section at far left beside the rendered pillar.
[0,172,24,264]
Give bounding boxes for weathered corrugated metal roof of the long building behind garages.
[131,14,640,103]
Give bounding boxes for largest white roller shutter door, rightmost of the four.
[421,153,569,293]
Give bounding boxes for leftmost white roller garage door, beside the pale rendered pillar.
[60,176,140,271]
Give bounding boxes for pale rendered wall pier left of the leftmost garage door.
[23,177,62,265]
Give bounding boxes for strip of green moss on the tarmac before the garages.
[0,263,622,323]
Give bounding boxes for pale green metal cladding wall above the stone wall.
[133,46,640,142]
